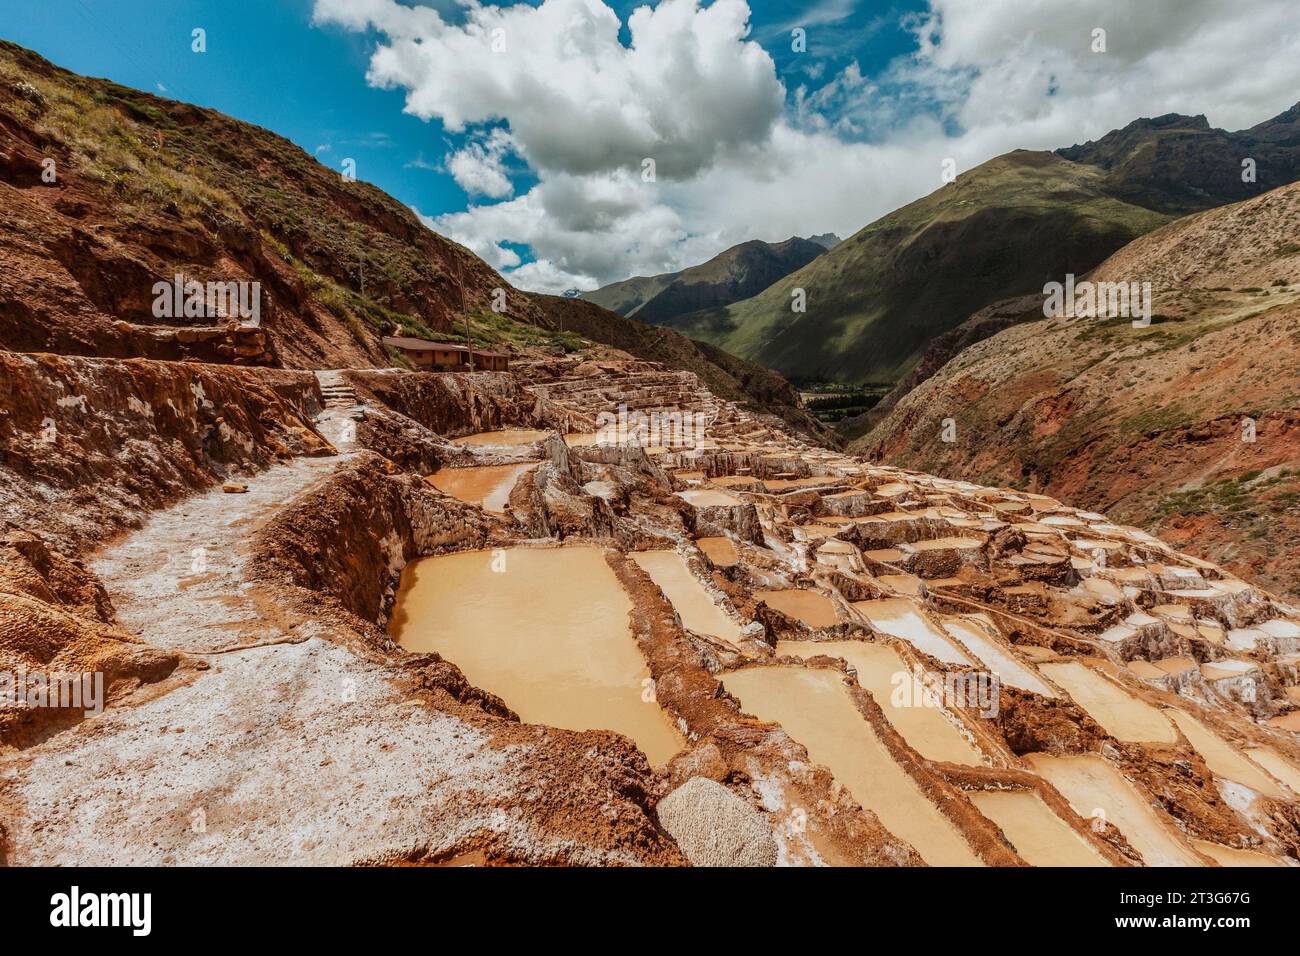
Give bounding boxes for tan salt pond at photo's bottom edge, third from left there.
[1024,753,1203,866]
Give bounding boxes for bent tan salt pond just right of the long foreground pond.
[776,641,983,766]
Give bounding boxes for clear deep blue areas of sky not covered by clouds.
[0,0,923,255]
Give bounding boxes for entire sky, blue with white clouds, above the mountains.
[0,0,1300,291]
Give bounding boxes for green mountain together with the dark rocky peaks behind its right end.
[664,107,1300,384]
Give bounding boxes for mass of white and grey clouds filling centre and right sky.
[313,0,1300,291]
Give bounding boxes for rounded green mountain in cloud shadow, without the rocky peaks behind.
[667,151,1169,384]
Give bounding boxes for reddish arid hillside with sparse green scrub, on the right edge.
[854,186,1300,594]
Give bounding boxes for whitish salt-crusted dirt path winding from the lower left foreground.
[0,455,629,865]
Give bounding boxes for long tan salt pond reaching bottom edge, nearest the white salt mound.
[723,667,982,866]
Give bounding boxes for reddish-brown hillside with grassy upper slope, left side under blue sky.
[0,44,520,368]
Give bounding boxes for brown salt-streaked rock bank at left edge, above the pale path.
[0,351,333,553]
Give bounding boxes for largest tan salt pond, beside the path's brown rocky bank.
[389,548,683,765]
